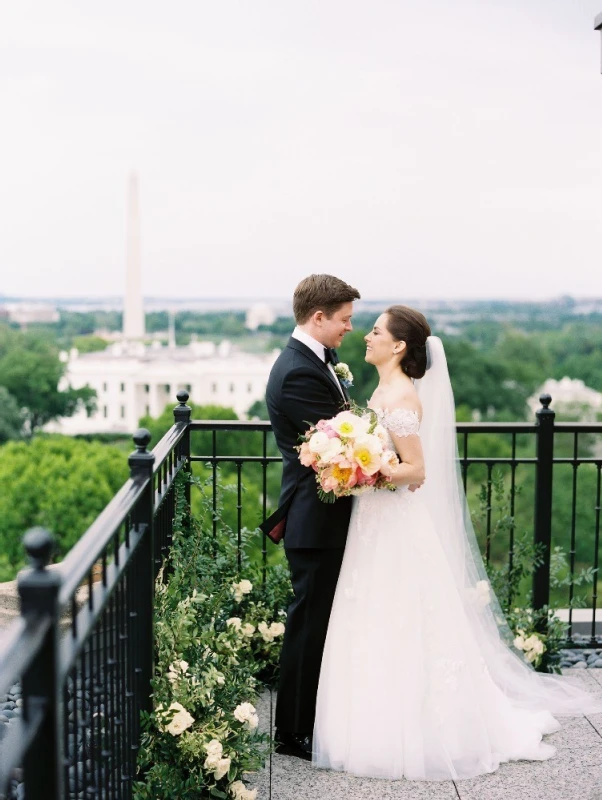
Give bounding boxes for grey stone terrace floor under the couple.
[249,669,602,800]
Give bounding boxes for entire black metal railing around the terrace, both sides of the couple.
[0,392,602,800]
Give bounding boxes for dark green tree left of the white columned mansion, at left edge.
[0,328,96,435]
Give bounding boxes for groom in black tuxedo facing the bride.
[261,275,360,760]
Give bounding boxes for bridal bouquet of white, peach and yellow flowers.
[297,408,399,503]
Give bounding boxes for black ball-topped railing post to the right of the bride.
[533,394,556,609]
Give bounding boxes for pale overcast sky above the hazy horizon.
[0,0,602,301]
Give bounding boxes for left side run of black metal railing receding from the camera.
[0,393,190,800]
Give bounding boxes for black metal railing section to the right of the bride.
[457,395,602,646]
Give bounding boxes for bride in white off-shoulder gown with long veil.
[313,306,601,780]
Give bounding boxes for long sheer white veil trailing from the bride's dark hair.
[416,336,602,714]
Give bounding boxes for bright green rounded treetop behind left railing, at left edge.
[0,436,128,580]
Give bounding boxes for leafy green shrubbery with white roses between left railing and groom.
[135,479,290,800]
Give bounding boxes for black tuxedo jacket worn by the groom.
[261,337,351,549]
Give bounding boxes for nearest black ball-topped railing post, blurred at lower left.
[17,528,64,800]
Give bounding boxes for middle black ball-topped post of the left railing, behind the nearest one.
[128,428,155,711]
